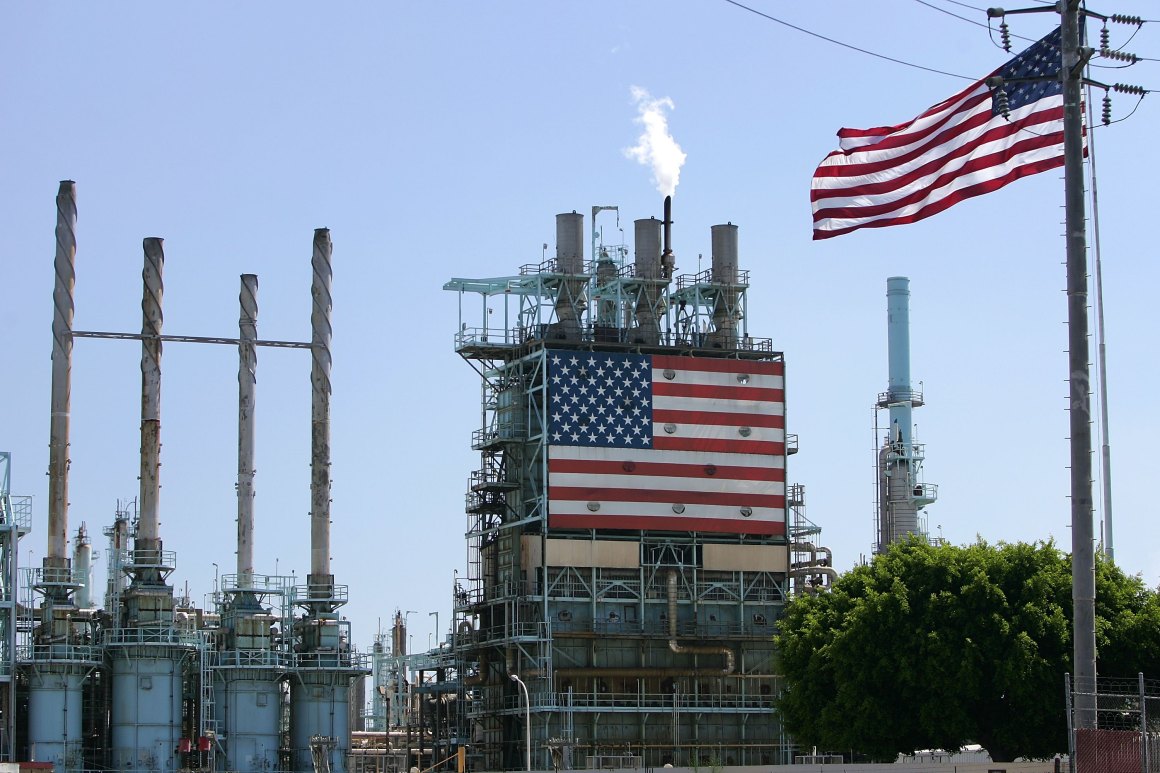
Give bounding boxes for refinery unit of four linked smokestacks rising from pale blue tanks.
[0,181,369,773]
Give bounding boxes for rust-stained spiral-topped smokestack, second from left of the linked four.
[133,237,165,583]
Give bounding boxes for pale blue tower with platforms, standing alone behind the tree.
[873,276,938,554]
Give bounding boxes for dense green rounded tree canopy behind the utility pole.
[777,540,1160,761]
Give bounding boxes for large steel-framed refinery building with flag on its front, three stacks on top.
[444,200,828,770]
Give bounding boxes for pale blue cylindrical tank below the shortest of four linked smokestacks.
[213,669,282,773]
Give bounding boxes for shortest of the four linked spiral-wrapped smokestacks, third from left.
[238,274,258,588]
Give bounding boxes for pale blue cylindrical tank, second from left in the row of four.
[109,645,186,772]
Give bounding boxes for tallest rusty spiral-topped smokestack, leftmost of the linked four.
[44,180,77,589]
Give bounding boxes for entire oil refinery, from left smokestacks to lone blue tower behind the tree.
[0,181,951,773]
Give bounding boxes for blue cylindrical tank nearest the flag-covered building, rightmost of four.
[290,669,351,773]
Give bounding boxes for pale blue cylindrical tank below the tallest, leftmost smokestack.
[28,663,89,771]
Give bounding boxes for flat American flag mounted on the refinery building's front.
[548,351,785,535]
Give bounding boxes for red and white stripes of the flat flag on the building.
[548,355,785,535]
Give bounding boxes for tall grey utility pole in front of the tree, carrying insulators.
[1060,0,1096,729]
